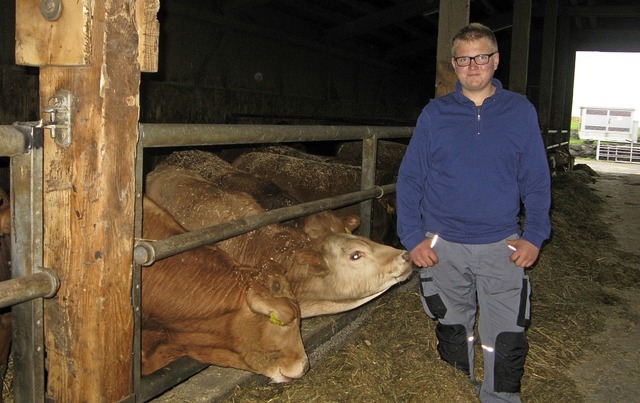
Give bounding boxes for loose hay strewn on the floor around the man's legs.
[229,171,640,403]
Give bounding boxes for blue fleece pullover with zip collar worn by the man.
[397,78,551,251]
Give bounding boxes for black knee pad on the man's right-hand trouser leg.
[493,332,529,393]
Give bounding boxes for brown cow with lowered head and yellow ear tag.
[142,197,309,382]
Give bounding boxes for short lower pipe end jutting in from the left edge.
[0,269,60,308]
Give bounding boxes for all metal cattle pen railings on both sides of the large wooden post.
[0,121,413,401]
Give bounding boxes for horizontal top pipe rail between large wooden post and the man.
[140,123,413,147]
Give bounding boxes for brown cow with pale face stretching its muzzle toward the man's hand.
[146,164,412,318]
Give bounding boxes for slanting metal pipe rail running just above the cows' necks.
[133,184,396,266]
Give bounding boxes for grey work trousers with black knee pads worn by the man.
[420,234,531,402]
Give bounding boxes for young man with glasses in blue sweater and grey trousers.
[397,23,551,402]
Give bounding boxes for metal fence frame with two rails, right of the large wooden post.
[132,123,413,399]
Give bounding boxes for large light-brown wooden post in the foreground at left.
[16,0,159,402]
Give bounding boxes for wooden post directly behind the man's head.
[436,0,470,97]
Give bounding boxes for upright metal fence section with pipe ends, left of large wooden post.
[0,122,49,402]
